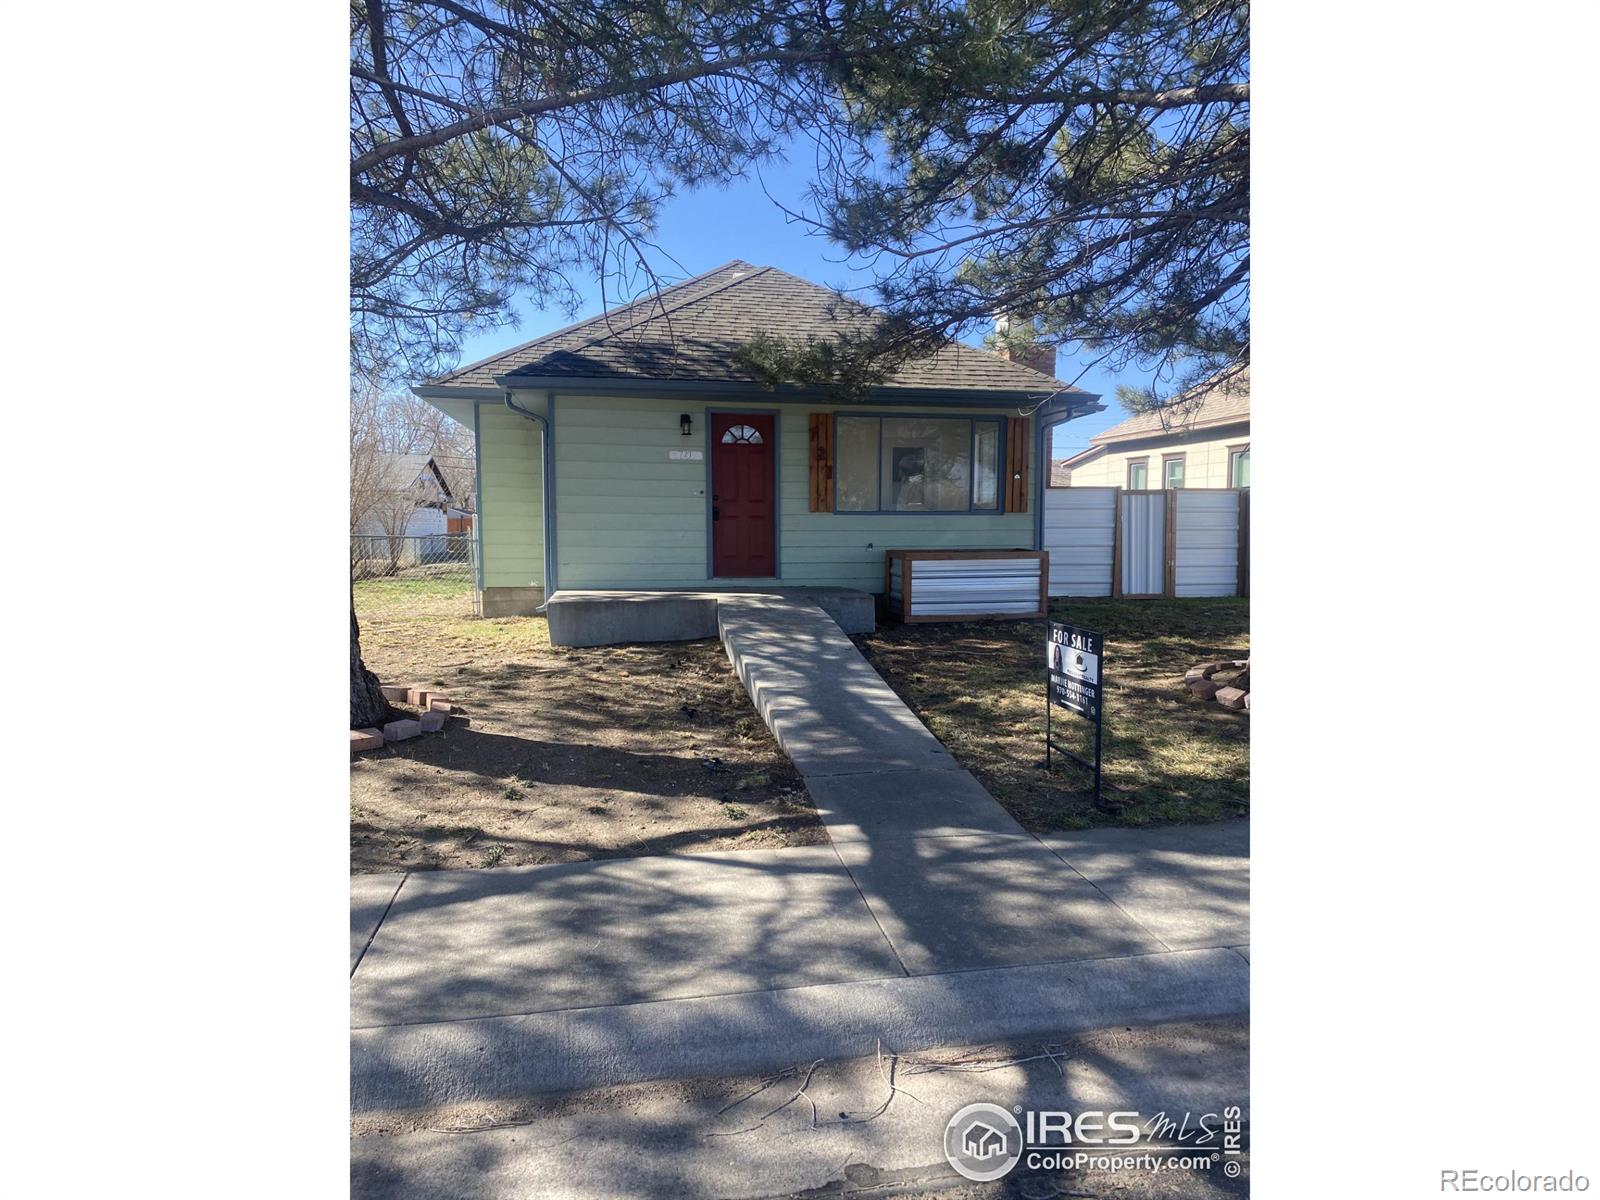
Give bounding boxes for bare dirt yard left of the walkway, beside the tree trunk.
[350,616,827,874]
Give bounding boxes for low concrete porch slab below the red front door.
[547,587,877,646]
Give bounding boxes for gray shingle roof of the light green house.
[430,259,1086,395]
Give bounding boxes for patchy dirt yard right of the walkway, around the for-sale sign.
[854,600,1250,832]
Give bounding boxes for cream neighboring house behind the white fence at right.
[1050,371,1250,490]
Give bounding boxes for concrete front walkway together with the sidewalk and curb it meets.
[350,597,1248,1112]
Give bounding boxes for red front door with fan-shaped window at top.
[710,413,778,579]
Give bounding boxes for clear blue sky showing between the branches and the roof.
[461,153,1149,458]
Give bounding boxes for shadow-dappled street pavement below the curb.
[350,1018,1250,1200]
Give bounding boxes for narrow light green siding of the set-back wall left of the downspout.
[477,397,544,587]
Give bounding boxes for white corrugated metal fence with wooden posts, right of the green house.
[1043,488,1250,597]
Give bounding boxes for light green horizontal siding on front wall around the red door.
[537,395,1034,592]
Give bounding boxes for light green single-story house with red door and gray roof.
[413,261,1099,616]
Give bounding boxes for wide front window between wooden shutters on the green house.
[835,416,1002,512]
